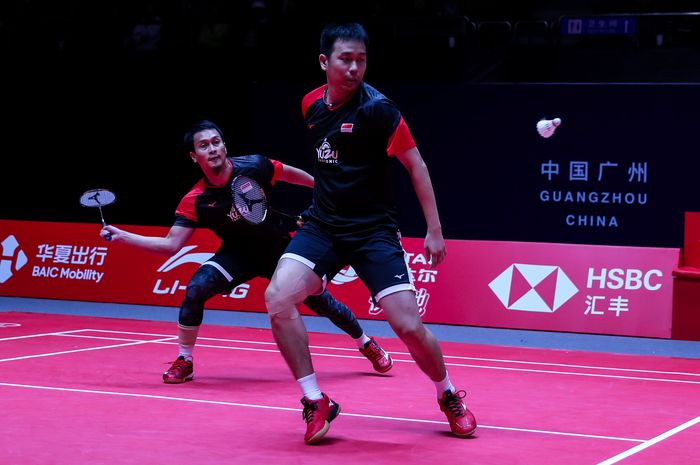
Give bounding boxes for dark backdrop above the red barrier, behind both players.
[0,0,700,247]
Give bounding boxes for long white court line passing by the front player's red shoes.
[0,382,645,443]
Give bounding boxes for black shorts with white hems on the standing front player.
[282,221,415,302]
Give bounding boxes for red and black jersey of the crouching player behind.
[175,155,289,245]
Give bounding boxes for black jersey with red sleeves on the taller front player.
[302,82,416,232]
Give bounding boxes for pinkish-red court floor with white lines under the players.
[0,312,700,465]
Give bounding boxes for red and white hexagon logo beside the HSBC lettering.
[489,263,578,313]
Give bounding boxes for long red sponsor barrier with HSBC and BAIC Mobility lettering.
[0,220,680,338]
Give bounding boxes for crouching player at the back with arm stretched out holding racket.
[100,121,393,383]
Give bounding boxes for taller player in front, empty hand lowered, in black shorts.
[265,23,476,443]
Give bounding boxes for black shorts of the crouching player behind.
[202,238,291,289]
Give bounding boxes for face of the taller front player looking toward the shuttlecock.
[321,40,367,93]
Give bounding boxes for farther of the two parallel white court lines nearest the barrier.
[49,329,700,379]
